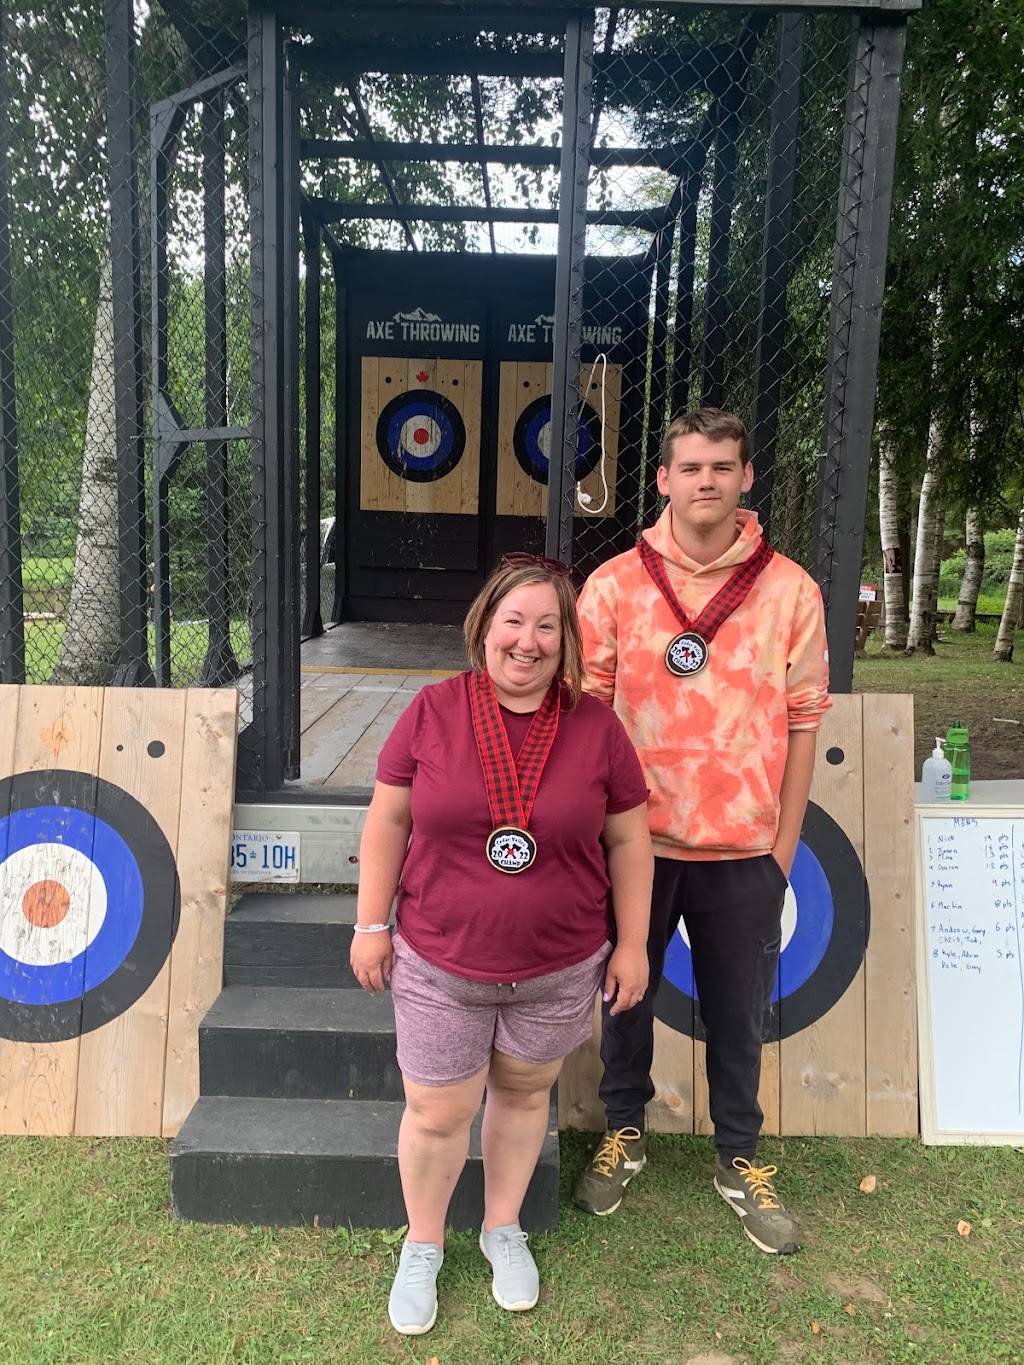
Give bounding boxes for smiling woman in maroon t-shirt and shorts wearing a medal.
[351,554,653,1335]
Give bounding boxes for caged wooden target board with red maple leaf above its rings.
[359,355,483,516]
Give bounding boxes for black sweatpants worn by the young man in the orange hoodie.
[599,854,786,1164]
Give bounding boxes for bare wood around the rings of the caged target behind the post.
[497,360,623,517]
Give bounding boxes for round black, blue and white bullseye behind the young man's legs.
[654,803,870,1043]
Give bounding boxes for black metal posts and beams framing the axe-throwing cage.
[0,0,920,790]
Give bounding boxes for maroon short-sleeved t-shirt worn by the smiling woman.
[377,673,647,981]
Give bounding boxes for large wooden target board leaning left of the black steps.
[0,687,238,1136]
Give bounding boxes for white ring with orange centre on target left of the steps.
[0,844,106,966]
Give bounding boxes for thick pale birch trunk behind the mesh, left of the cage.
[51,246,120,687]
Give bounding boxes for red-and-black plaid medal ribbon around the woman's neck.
[470,672,561,830]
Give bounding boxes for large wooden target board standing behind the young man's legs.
[558,695,919,1137]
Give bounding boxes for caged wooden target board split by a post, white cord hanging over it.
[496,360,623,520]
